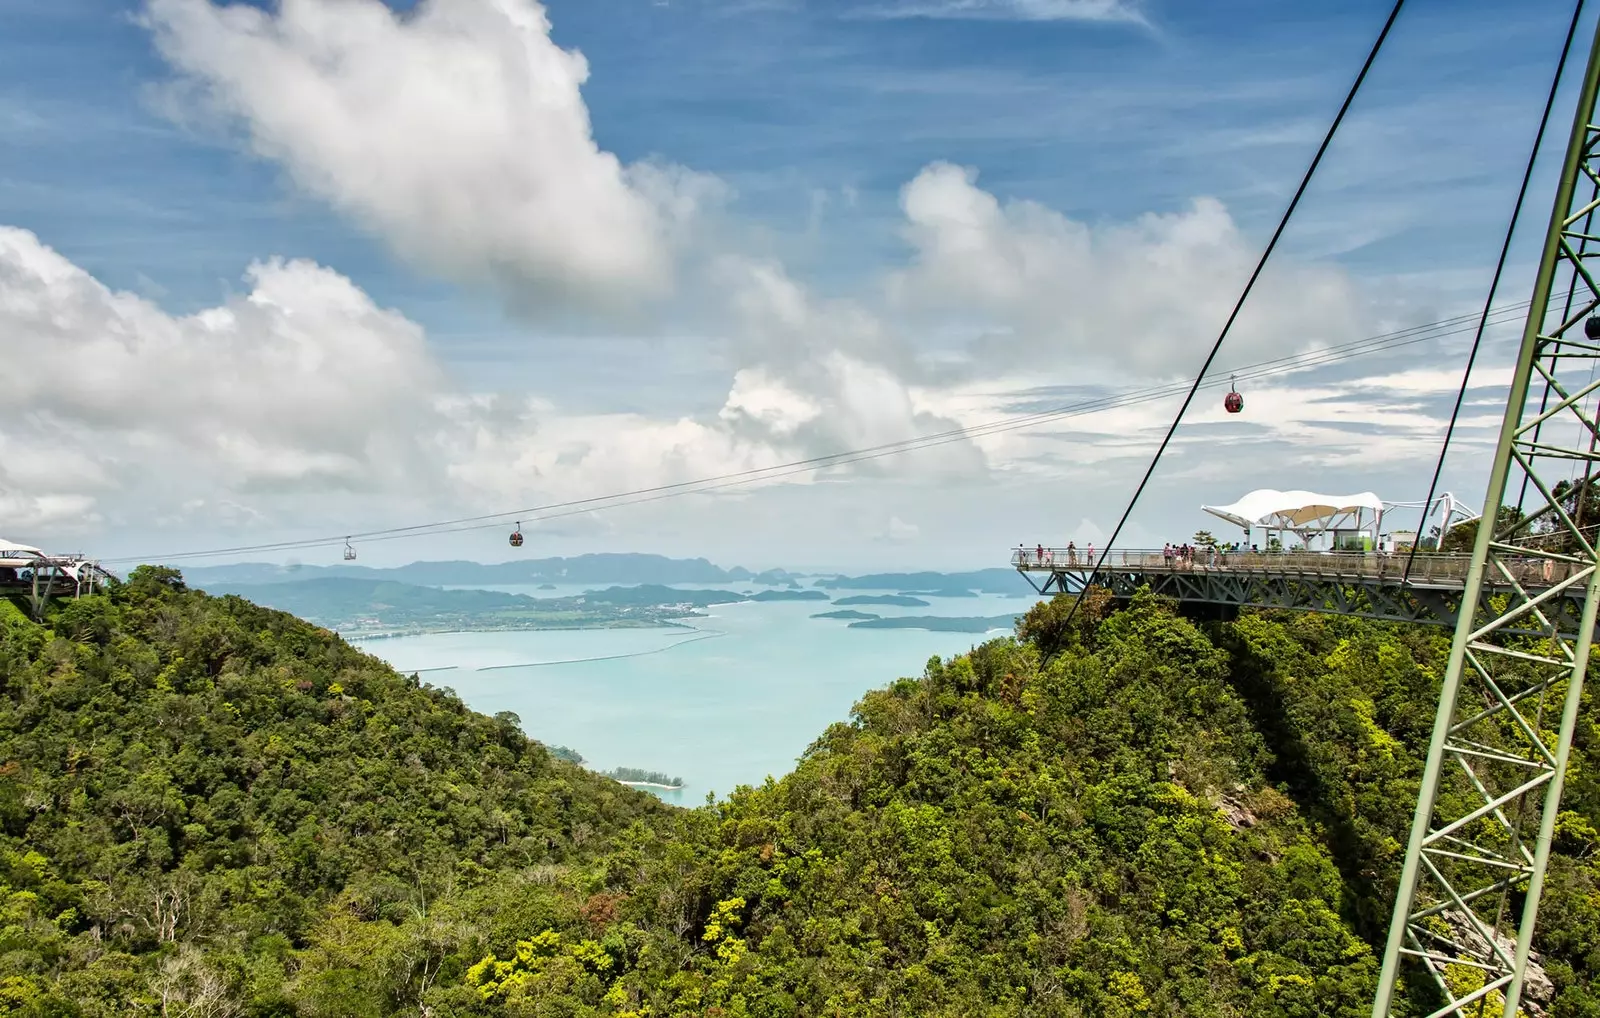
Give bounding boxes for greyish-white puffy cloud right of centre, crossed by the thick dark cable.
[890,163,1374,376]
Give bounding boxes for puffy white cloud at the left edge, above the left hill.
[0,227,440,511]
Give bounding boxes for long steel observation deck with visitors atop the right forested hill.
[1011,547,1600,639]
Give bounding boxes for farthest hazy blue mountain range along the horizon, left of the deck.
[184,552,798,587]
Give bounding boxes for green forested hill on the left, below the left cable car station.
[0,568,666,1016]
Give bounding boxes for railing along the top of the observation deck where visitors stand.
[1011,547,1579,587]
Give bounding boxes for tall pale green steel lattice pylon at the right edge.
[1373,17,1600,1018]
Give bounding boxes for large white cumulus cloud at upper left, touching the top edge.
[146,0,718,306]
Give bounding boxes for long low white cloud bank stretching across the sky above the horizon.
[0,214,1499,565]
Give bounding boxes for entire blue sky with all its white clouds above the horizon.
[0,0,1592,571]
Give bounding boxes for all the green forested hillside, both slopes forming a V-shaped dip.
[0,570,1600,1018]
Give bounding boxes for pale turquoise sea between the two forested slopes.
[360,586,1038,805]
